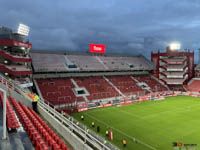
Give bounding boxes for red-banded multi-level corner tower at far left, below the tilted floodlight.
[0,27,33,87]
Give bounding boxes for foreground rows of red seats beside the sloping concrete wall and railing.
[10,97,69,150]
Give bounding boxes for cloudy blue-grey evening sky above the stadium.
[0,0,200,60]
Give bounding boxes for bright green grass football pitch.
[72,96,200,150]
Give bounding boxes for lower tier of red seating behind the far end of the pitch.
[36,75,168,108]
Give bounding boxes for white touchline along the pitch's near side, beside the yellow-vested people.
[85,114,157,150]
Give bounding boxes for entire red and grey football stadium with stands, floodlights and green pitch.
[0,25,200,150]
